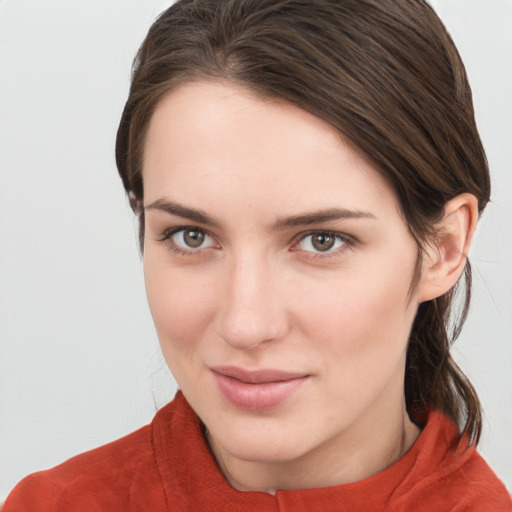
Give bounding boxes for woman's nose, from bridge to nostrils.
[217,255,289,350]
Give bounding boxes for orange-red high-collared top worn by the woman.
[3,393,512,512]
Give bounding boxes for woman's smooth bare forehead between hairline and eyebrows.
[143,82,397,221]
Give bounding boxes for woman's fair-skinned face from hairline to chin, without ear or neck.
[143,82,417,468]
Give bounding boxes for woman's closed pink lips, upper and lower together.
[210,366,309,411]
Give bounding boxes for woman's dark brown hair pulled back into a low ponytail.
[116,0,490,443]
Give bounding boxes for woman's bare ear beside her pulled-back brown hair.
[417,194,478,303]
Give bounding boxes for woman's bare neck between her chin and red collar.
[209,403,420,494]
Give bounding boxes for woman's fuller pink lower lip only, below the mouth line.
[213,372,308,411]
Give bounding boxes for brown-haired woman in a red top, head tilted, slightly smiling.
[5,0,512,512]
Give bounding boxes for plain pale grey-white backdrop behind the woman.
[0,0,512,498]
